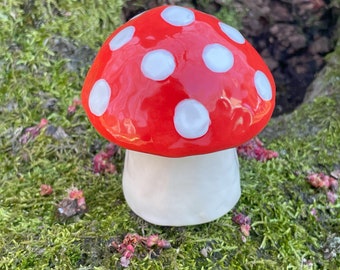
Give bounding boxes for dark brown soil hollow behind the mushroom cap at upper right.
[124,0,340,116]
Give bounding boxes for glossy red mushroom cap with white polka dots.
[82,6,275,157]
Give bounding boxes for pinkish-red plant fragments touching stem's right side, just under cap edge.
[237,137,279,162]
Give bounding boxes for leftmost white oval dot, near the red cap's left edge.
[89,79,111,116]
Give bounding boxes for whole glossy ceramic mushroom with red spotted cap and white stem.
[82,6,275,226]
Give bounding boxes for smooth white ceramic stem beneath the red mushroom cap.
[123,148,241,226]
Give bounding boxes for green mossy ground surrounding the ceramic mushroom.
[0,0,340,269]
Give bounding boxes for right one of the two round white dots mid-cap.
[202,43,234,72]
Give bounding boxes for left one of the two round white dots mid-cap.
[141,49,176,81]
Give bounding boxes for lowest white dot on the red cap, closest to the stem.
[174,99,210,139]
